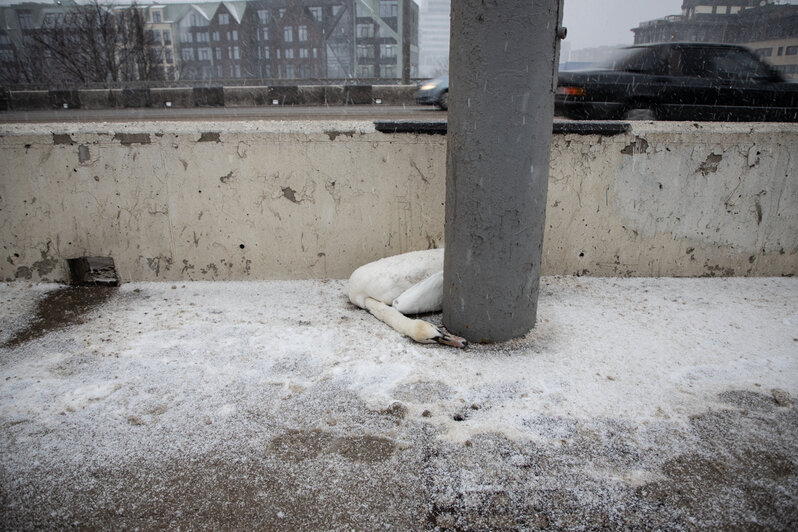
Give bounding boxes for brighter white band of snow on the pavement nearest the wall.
[0,277,798,454]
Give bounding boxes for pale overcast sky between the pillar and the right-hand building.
[563,0,682,50]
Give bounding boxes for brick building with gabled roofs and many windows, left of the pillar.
[173,0,418,80]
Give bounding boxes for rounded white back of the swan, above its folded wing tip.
[349,249,443,308]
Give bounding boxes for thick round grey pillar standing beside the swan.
[443,0,562,342]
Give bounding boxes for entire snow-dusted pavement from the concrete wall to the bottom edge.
[0,277,798,528]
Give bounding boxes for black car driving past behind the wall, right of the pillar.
[555,43,798,122]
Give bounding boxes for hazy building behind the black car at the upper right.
[632,0,798,79]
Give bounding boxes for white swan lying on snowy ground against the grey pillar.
[349,249,468,347]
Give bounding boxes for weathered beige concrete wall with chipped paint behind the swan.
[0,121,798,281]
